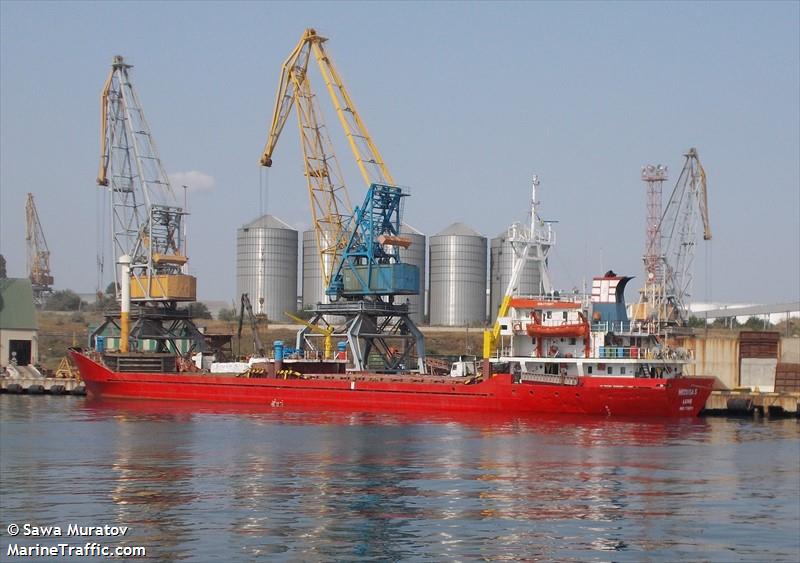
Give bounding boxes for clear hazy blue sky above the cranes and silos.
[0,1,800,302]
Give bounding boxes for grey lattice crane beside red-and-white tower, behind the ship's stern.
[636,148,711,328]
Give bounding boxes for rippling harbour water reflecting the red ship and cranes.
[0,396,800,561]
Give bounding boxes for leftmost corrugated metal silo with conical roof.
[236,215,297,321]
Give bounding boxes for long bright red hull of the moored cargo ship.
[70,350,714,417]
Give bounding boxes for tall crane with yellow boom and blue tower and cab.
[260,29,425,372]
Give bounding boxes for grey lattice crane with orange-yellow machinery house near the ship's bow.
[93,55,204,352]
